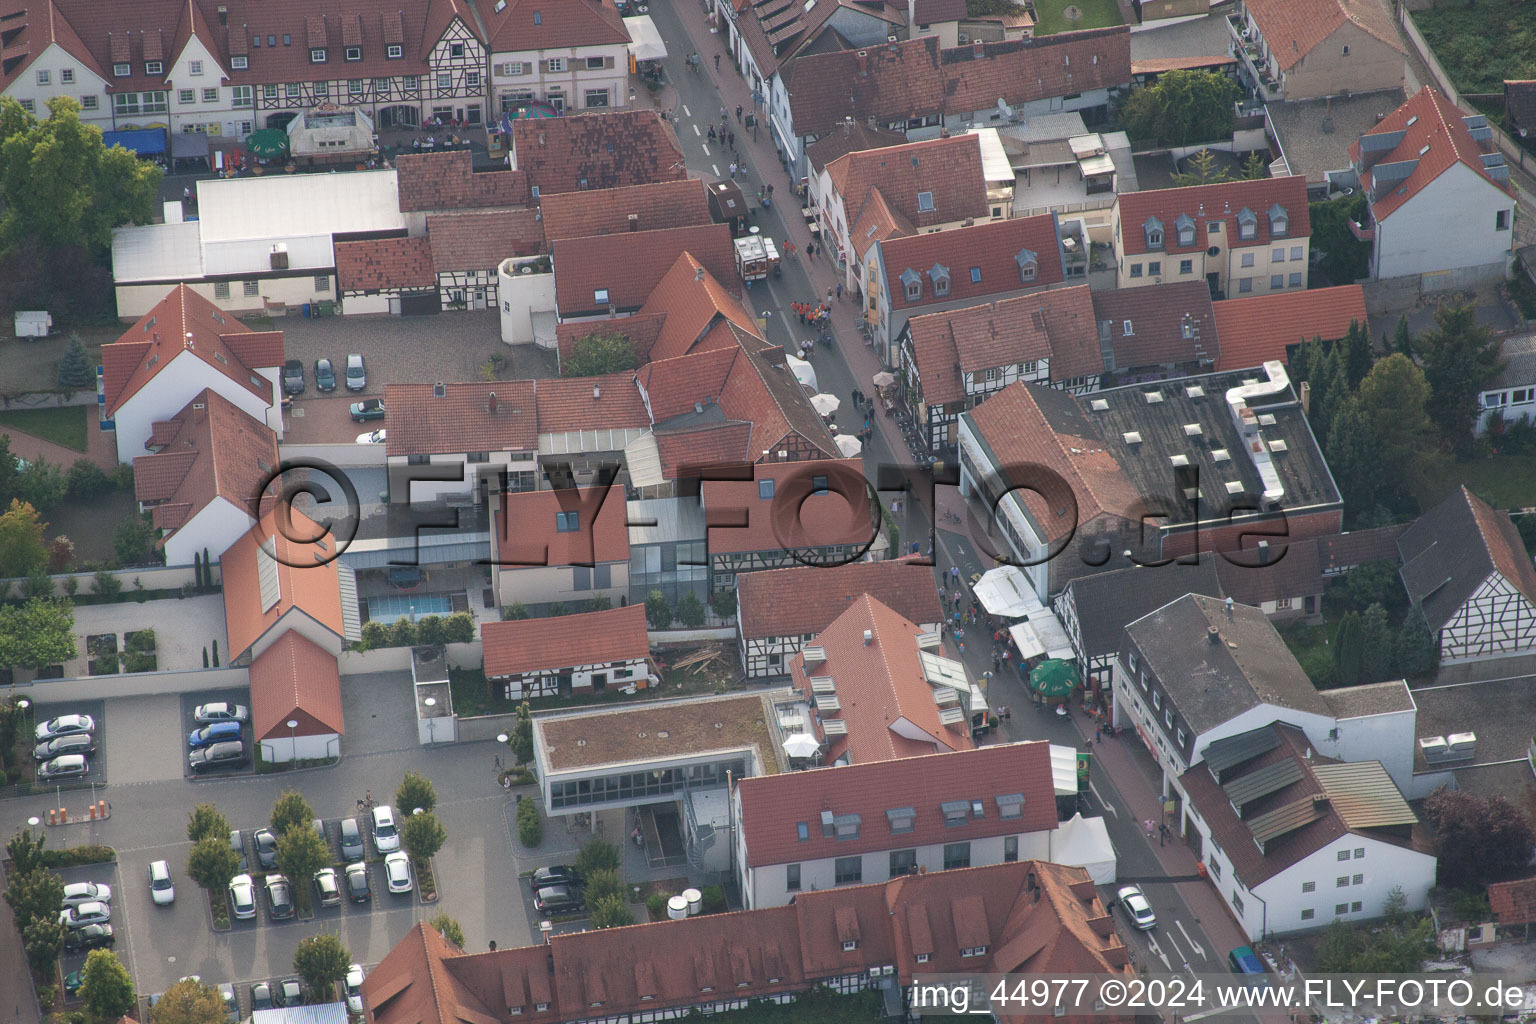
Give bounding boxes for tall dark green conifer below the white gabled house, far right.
[1415,302,1504,454]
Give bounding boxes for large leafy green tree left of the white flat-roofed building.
[0,97,160,256]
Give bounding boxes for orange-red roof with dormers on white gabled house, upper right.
[1349,87,1513,221]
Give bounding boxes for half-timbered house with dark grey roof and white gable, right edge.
[1398,487,1536,662]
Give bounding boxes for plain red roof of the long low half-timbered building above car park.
[481,605,651,679]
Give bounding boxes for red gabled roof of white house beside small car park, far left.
[101,284,283,415]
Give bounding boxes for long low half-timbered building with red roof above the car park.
[481,605,656,700]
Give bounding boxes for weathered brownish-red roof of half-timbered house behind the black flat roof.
[908,287,1099,405]
